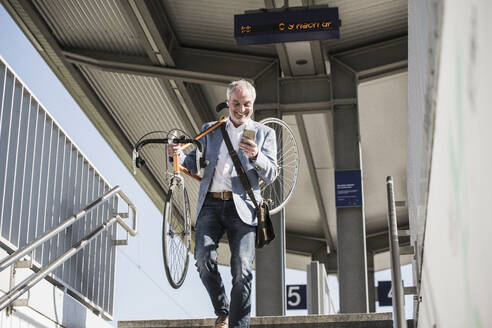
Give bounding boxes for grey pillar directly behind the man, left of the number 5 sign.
[254,65,286,316]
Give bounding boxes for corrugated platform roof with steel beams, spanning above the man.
[0,0,408,270]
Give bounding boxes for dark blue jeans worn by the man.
[195,198,256,327]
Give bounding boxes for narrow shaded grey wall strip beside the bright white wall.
[407,0,442,288]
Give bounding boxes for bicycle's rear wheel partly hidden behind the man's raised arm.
[260,117,299,214]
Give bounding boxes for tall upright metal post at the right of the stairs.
[386,176,407,328]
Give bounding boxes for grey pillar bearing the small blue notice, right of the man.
[330,58,368,313]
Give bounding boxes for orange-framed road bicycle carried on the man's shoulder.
[133,117,299,289]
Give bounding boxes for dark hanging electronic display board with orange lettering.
[234,7,341,45]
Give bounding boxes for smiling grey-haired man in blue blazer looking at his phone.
[168,80,278,328]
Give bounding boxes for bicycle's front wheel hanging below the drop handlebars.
[162,181,191,289]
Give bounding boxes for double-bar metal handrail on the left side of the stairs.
[0,186,137,311]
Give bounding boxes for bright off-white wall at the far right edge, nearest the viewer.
[409,0,492,328]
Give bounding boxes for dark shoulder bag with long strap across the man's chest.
[221,124,275,248]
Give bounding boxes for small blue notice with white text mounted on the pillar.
[335,170,362,207]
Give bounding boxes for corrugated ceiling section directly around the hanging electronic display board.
[163,0,408,56]
